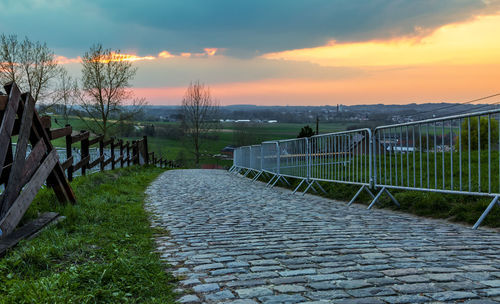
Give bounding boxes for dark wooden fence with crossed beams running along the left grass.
[0,83,174,256]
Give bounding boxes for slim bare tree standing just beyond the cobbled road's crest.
[182,81,219,165]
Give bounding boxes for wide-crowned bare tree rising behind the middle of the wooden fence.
[78,44,146,137]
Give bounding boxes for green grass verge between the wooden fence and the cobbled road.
[0,167,175,303]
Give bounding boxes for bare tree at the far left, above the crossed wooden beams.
[0,34,61,109]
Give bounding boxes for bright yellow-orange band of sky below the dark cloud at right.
[262,15,500,67]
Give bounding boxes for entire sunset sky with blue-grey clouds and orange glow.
[0,0,500,105]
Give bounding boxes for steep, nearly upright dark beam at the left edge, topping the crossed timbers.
[0,83,21,178]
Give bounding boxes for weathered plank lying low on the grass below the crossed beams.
[0,212,59,257]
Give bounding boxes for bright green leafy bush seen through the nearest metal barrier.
[455,117,498,150]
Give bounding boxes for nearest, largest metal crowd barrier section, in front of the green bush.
[369,110,500,228]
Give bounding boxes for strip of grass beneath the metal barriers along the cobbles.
[254,172,500,227]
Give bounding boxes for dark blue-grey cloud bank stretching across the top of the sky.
[0,0,500,56]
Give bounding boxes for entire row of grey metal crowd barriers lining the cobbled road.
[230,110,500,229]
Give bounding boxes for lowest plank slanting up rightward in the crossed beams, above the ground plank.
[0,150,58,235]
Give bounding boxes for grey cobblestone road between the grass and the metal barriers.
[146,170,500,304]
